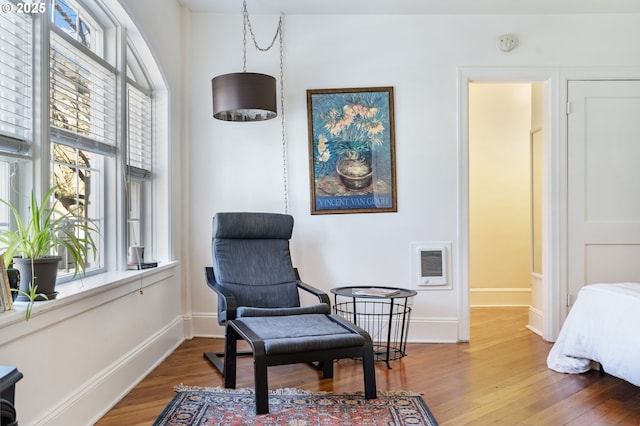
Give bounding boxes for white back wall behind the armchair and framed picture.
[185,13,640,341]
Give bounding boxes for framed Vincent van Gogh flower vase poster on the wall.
[307,87,398,214]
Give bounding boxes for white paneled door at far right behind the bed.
[567,81,640,305]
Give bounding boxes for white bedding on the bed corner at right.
[547,283,640,386]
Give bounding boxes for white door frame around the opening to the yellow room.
[456,67,567,341]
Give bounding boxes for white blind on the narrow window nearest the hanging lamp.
[127,83,152,178]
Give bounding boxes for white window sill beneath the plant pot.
[0,261,179,332]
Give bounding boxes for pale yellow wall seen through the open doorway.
[469,82,540,318]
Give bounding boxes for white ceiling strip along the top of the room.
[178,0,640,15]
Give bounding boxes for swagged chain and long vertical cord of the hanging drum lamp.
[242,0,289,213]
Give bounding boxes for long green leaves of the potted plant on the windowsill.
[0,187,97,277]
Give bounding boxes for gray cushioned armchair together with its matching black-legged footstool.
[204,213,376,414]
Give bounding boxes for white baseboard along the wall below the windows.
[35,316,184,426]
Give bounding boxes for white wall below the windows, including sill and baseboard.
[0,264,184,426]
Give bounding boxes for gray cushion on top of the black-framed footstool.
[233,314,364,355]
